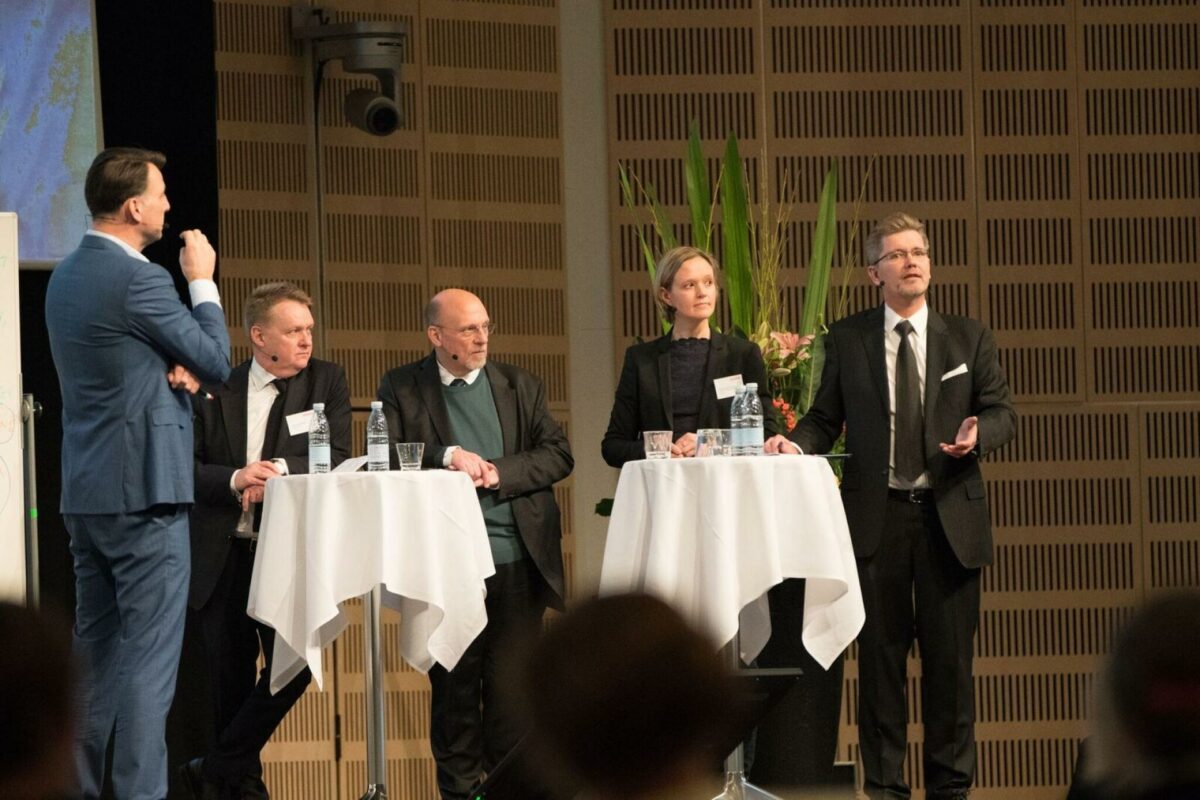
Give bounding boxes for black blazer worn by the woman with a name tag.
[600,331,780,469]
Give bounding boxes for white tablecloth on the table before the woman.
[600,456,864,668]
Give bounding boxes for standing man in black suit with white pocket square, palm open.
[767,213,1016,800]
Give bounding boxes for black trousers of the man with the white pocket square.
[858,499,979,800]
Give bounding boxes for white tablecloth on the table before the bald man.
[247,470,496,692]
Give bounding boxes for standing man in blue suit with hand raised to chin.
[46,148,229,800]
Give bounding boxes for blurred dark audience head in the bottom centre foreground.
[521,595,742,799]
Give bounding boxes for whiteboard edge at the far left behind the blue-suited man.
[0,211,25,603]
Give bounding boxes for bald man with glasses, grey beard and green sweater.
[379,289,575,800]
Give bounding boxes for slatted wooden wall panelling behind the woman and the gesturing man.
[605,0,1200,800]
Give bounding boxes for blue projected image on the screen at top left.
[0,0,98,261]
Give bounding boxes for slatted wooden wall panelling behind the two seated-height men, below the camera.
[216,0,574,800]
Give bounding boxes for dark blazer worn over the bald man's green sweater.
[378,354,575,609]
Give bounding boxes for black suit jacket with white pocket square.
[791,306,1016,567]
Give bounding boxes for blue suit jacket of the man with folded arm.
[46,236,229,513]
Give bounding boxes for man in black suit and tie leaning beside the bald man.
[181,283,350,800]
